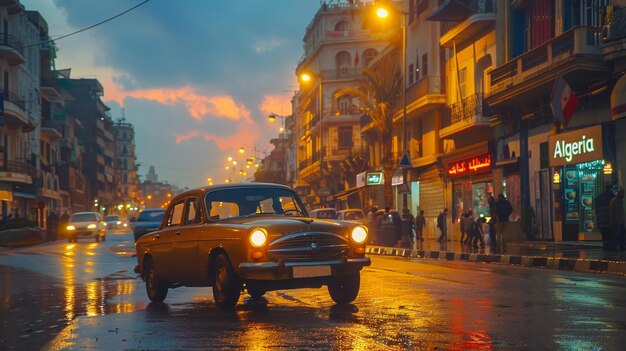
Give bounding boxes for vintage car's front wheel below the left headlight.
[213,254,241,309]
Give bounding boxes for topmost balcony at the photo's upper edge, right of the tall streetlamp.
[428,0,496,48]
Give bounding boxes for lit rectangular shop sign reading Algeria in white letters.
[548,125,603,167]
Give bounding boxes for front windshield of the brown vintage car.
[205,187,306,220]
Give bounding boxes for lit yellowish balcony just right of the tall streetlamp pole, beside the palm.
[394,76,446,122]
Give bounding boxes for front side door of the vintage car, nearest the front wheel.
[174,196,206,282]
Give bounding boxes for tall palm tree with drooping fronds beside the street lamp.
[334,55,402,207]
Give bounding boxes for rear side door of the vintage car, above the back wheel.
[152,199,185,282]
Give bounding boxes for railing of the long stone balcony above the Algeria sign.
[490,26,601,93]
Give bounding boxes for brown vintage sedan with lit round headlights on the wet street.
[130,183,370,309]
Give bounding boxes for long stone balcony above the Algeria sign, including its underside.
[485,26,610,106]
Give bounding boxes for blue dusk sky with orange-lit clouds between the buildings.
[21,0,320,187]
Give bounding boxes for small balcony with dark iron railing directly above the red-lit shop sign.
[439,94,492,138]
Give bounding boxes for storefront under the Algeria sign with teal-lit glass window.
[548,125,613,241]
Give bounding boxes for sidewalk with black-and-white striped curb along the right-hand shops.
[366,239,626,275]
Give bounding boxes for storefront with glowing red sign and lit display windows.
[446,152,493,221]
